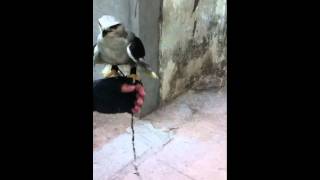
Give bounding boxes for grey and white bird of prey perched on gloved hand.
[93,15,158,81]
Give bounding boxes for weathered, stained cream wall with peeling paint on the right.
[160,0,227,103]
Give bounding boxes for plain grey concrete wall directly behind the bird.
[93,0,161,116]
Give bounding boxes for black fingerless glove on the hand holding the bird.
[93,77,144,114]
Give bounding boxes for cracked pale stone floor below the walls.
[93,89,227,180]
